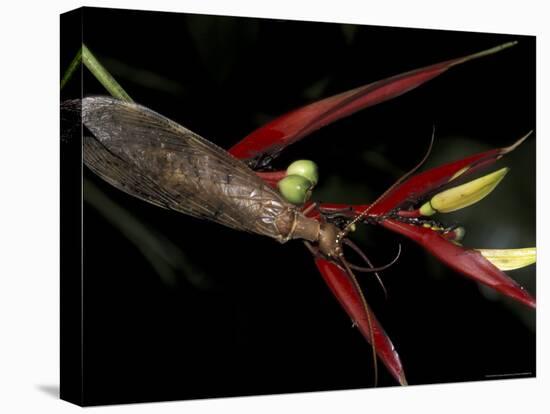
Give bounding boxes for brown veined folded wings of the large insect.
[82,97,294,241]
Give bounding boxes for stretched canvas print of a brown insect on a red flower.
[60,7,536,405]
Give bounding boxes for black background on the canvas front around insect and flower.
[61,8,535,404]
